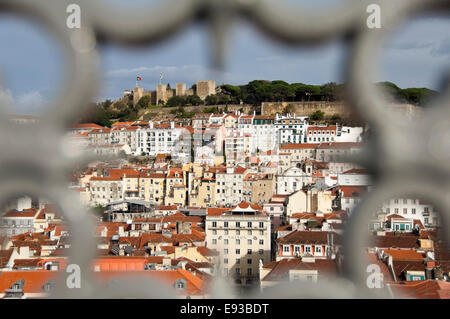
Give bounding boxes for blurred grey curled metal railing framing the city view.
[0,0,450,298]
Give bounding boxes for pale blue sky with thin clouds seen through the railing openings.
[0,0,450,114]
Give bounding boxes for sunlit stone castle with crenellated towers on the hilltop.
[124,80,216,105]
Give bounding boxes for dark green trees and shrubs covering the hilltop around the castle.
[79,80,438,127]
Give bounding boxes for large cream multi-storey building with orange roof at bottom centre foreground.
[205,202,271,286]
